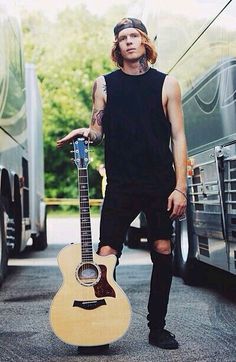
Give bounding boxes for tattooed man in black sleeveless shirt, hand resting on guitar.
[57,18,186,349]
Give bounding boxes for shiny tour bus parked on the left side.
[0,0,47,283]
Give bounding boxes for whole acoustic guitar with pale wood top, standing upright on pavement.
[50,138,131,347]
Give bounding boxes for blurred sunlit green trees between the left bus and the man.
[22,6,129,198]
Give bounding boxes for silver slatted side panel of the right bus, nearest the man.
[188,148,229,270]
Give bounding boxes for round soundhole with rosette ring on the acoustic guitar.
[76,263,101,287]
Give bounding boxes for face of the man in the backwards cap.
[118,28,146,62]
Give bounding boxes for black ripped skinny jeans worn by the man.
[98,182,174,329]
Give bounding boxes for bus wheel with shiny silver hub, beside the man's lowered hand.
[174,220,200,285]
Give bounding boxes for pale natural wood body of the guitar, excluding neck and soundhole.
[50,244,131,346]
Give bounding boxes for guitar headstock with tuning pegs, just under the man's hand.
[72,137,89,169]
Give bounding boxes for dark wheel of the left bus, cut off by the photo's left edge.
[0,206,8,285]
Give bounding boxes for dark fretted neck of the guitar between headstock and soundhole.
[78,168,93,262]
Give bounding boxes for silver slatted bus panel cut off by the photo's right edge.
[218,141,236,274]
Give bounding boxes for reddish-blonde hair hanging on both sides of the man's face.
[111,29,157,68]
